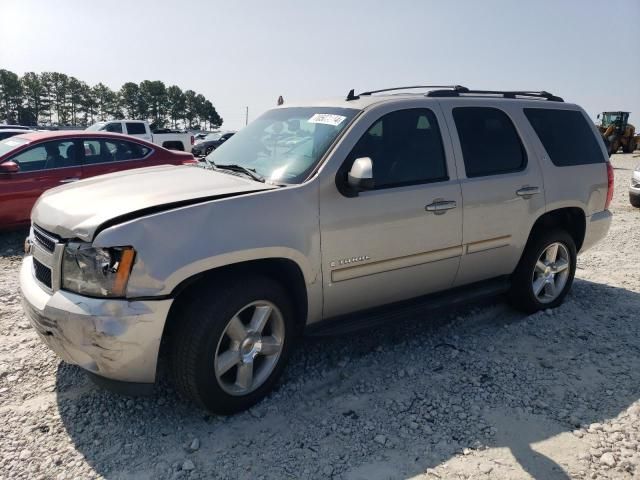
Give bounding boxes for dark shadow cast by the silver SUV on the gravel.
[57,280,640,479]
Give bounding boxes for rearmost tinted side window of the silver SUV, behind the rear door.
[524,108,606,167]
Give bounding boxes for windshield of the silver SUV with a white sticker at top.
[207,107,358,183]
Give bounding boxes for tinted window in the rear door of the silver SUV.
[453,107,527,178]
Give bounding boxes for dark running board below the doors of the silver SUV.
[305,277,511,336]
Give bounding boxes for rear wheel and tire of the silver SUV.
[509,229,576,313]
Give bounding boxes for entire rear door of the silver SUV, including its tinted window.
[442,100,545,286]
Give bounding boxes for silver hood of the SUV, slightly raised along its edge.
[31,165,277,241]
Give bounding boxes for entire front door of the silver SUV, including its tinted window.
[320,102,462,318]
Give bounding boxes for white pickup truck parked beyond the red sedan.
[87,120,194,152]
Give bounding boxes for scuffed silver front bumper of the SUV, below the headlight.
[20,255,172,391]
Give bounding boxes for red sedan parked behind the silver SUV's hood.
[0,130,198,230]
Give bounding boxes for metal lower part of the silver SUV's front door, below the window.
[321,181,462,317]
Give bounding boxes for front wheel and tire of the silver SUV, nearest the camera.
[170,277,295,415]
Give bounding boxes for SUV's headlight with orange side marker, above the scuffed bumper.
[62,242,135,297]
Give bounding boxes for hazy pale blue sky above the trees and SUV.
[0,0,640,128]
